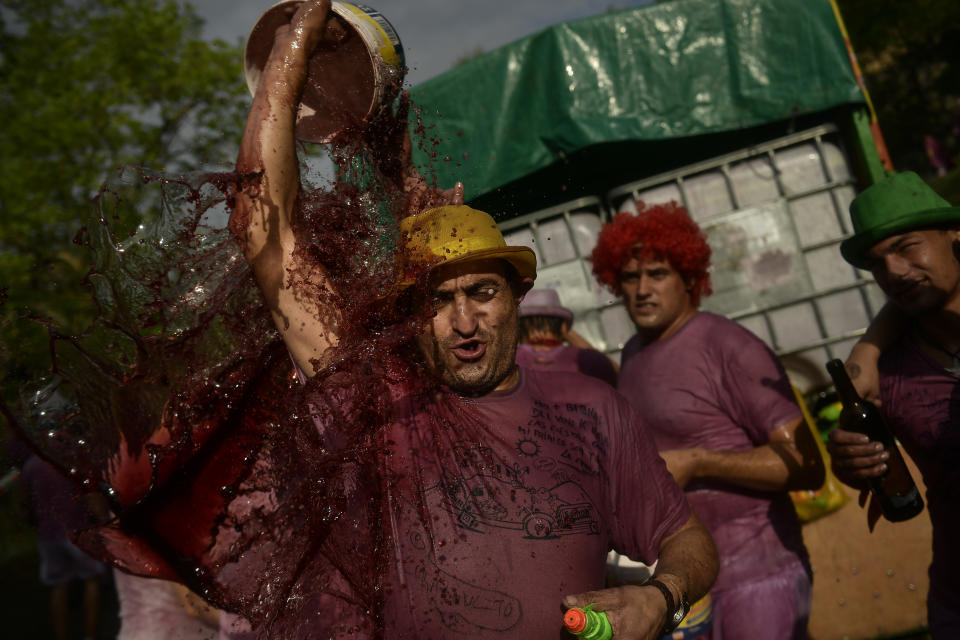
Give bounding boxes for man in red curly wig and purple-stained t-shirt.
[592,203,824,640]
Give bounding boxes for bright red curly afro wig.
[590,202,711,306]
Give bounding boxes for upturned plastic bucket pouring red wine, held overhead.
[243,0,406,143]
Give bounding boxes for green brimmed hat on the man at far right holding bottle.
[840,171,960,269]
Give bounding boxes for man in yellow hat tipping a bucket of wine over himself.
[225,0,717,639]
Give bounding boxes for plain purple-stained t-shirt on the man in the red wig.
[618,312,806,590]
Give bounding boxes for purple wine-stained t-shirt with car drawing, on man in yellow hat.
[302,369,690,640]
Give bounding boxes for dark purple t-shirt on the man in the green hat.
[880,338,960,611]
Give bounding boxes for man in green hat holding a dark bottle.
[830,173,960,639]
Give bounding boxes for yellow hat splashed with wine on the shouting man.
[399,205,537,287]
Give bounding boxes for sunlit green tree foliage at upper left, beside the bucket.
[0,0,249,384]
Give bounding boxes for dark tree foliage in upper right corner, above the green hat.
[837,0,960,175]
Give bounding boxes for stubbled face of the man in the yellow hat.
[417,259,520,396]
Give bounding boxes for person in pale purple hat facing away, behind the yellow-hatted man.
[517,289,617,387]
